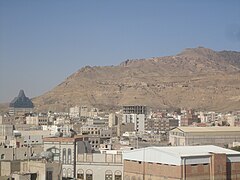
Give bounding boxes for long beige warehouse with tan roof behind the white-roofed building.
[169,126,240,147]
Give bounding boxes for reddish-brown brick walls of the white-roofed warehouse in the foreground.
[124,158,240,180]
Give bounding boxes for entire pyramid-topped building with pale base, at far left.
[9,90,34,116]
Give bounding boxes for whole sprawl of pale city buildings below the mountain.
[0,90,240,180]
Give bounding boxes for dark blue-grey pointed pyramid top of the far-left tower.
[9,90,34,108]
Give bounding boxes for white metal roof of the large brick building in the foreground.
[123,145,240,165]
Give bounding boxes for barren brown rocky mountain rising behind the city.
[32,47,240,111]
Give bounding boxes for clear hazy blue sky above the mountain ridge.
[0,0,240,102]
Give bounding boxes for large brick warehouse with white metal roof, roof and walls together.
[123,145,240,180]
